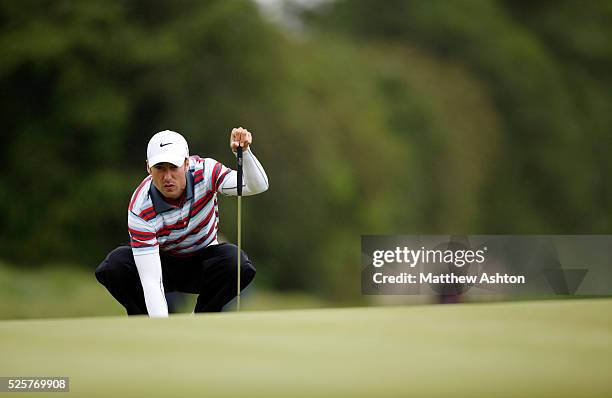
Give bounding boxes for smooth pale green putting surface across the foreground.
[0,299,612,397]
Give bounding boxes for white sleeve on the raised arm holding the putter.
[217,149,269,196]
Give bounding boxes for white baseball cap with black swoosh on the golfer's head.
[147,130,189,167]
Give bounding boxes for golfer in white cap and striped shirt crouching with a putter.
[96,127,268,317]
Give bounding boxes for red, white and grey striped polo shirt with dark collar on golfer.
[128,155,231,256]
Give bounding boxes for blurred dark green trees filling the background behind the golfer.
[0,0,612,318]
